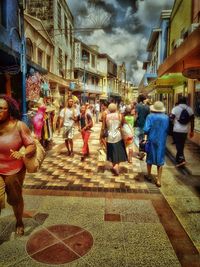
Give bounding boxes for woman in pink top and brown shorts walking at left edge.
[0,95,35,235]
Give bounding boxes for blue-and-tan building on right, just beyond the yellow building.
[139,10,173,110]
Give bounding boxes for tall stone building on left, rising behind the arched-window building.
[26,0,74,101]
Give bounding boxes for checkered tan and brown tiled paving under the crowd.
[24,124,159,193]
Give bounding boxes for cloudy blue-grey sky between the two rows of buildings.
[67,0,174,85]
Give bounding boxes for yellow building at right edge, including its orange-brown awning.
[158,0,200,144]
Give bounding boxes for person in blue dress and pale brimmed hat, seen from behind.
[144,101,169,187]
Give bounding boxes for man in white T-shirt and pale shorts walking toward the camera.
[58,98,77,156]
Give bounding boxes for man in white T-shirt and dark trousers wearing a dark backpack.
[171,96,194,167]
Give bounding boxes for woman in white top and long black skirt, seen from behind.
[103,103,127,175]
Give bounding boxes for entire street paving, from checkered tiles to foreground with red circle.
[0,123,200,267]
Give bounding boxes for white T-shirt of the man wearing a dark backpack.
[172,104,194,133]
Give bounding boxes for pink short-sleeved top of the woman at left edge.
[0,122,34,175]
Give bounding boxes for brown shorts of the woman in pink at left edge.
[0,168,26,208]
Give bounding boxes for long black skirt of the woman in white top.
[107,140,128,164]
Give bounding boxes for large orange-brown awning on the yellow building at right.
[158,27,200,79]
